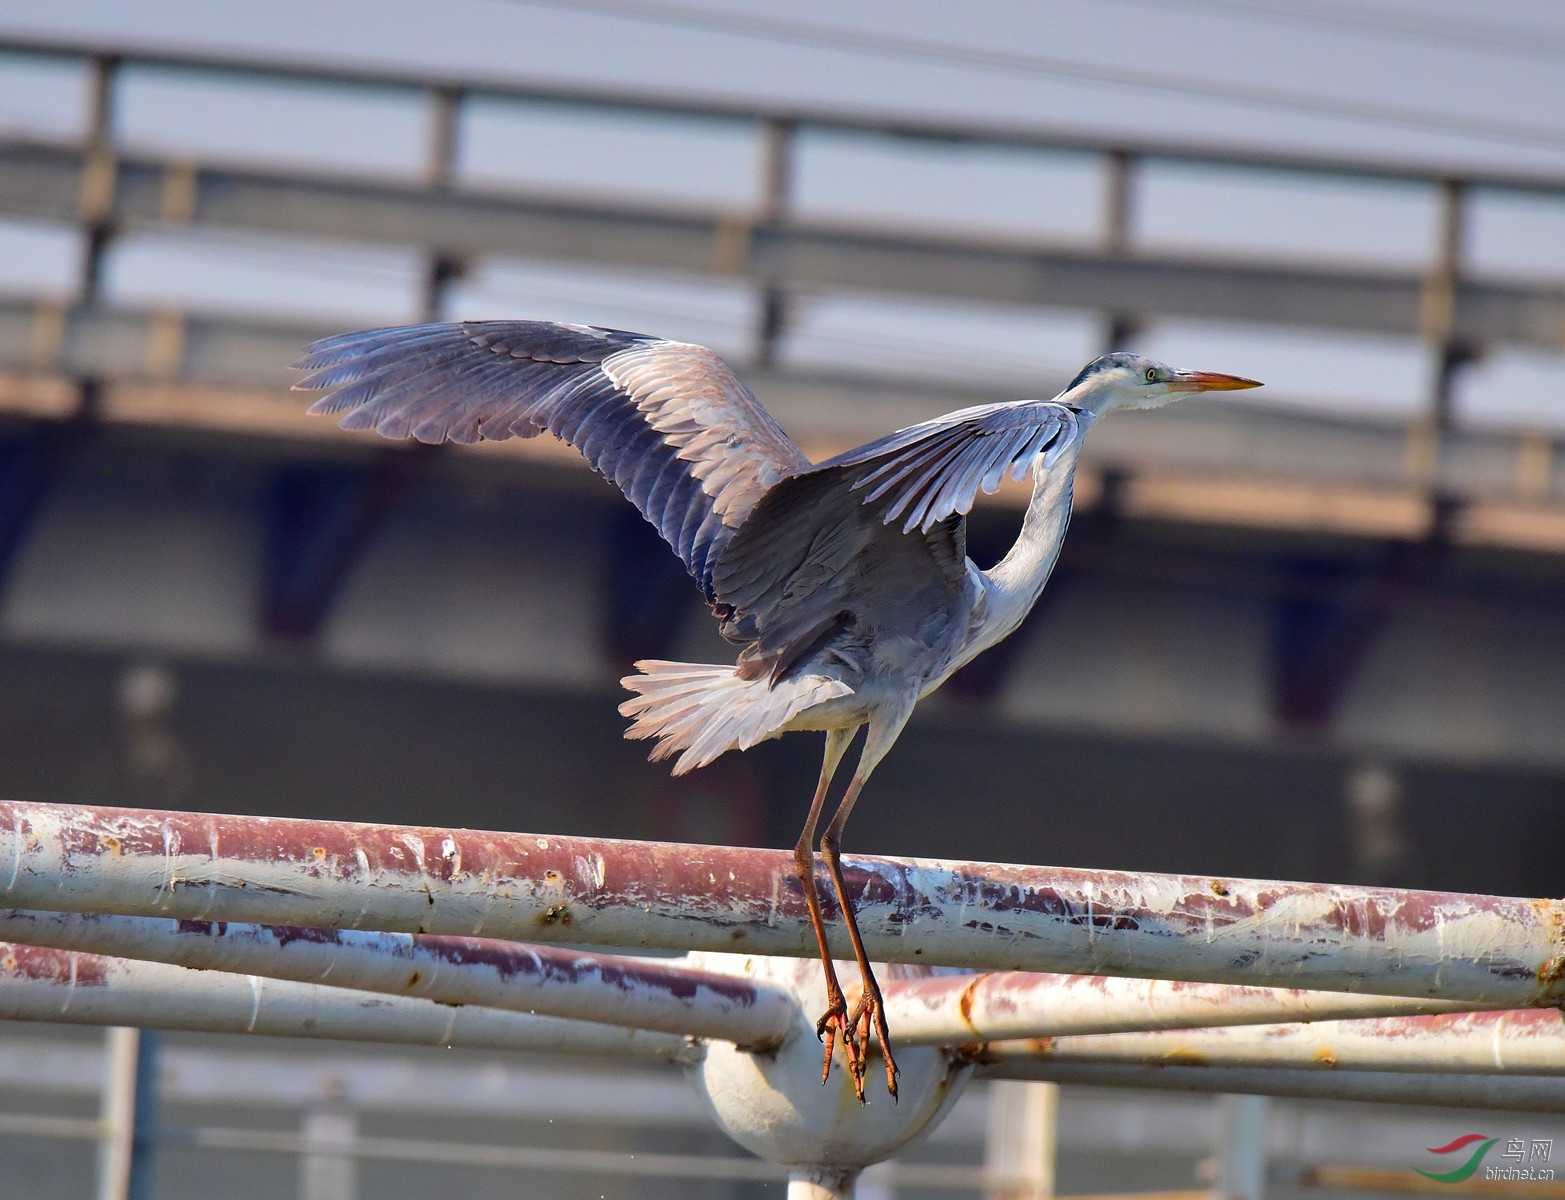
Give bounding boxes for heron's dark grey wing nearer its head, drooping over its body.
[712,402,1080,677]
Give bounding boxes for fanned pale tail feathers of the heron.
[620,659,853,774]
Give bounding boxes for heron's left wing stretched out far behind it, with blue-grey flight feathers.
[294,321,809,596]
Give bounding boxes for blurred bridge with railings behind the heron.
[0,42,1565,895]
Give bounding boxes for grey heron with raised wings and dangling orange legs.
[294,321,1260,1100]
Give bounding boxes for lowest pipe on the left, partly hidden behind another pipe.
[0,942,701,1065]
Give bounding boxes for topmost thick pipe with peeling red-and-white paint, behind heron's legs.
[0,803,1565,1008]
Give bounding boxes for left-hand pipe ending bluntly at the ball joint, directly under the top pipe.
[0,909,795,1048]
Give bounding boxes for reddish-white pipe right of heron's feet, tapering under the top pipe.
[876,963,1482,1045]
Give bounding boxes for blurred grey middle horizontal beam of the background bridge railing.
[0,142,1565,349]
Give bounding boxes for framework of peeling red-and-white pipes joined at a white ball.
[0,804,1565,1197]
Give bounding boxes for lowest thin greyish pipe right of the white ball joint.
[975,1059,1565,1112]
